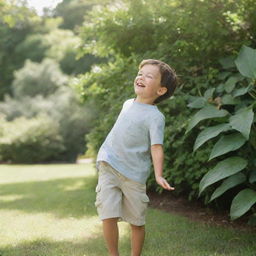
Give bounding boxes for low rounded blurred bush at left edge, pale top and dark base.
[0,114,65,163]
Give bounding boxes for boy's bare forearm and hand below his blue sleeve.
[151,144,174,190]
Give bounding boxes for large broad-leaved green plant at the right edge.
[187,46,256,220]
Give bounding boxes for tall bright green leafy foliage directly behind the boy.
[78,0,255,198]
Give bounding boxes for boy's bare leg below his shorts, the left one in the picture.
[103,218,119,256]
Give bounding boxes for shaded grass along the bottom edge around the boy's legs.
[0,216,255,256]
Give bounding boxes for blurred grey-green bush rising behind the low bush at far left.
[0,59,93,162]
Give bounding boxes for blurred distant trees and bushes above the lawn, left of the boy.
[0,0,102,163]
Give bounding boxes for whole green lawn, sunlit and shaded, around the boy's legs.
[0,164,256,256]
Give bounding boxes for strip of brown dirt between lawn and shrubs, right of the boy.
[148,191,256,232]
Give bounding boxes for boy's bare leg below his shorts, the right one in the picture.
[131,224,145,256]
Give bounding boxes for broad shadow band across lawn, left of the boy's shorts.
[0,177,97,218]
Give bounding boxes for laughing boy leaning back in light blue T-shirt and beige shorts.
[95,59,177,256]
